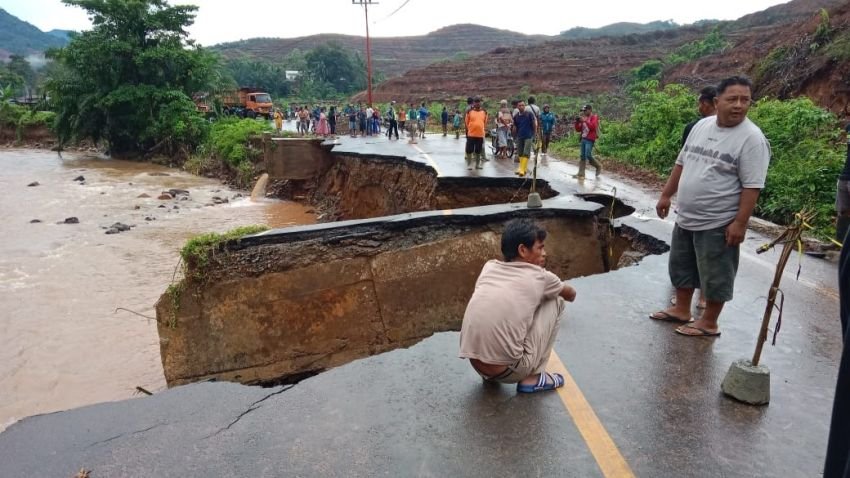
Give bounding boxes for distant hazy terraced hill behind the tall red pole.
[210,24,552,77]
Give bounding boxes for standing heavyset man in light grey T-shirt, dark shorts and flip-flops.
[650,76,770,337]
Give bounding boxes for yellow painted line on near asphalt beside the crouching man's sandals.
[546,350,635,478]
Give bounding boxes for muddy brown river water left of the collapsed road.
[0,149,315,430]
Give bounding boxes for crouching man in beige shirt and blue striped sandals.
[460,219,576,393]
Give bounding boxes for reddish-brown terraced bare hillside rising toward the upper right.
[354,0,850,113]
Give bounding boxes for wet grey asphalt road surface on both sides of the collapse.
[0,132,841,477]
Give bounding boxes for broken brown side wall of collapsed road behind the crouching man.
[157,208,606,385]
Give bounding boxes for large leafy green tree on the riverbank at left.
[47,0,217,155]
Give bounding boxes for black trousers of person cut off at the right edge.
[823,229,850,478]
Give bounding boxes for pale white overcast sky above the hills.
[0,0,785,45]
